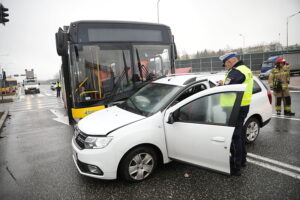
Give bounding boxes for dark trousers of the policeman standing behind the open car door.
[230,106,250,170]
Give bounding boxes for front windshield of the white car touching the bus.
[119,83,181,116]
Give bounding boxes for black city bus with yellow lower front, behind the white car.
[55,21,177,122]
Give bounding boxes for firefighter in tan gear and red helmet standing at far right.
[269,57,295,116]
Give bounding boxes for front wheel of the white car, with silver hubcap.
[119,146,157,182]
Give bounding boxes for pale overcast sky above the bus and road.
[0,0,300,79]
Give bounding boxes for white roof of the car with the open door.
[154,72,225,86]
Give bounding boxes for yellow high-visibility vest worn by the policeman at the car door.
[221,65,253,107]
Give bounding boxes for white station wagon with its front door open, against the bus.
[72,74,272,182]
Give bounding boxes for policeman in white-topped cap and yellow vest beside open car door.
[219,53,253,176]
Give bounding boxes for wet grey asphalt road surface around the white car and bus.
[0,86,300,200]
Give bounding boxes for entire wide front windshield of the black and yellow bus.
[70,43,171,103]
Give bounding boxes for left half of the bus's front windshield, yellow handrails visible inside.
[71,44,132,102]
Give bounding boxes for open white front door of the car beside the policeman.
[164,84,246,173]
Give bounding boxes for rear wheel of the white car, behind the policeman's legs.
[245,117,260,144]
